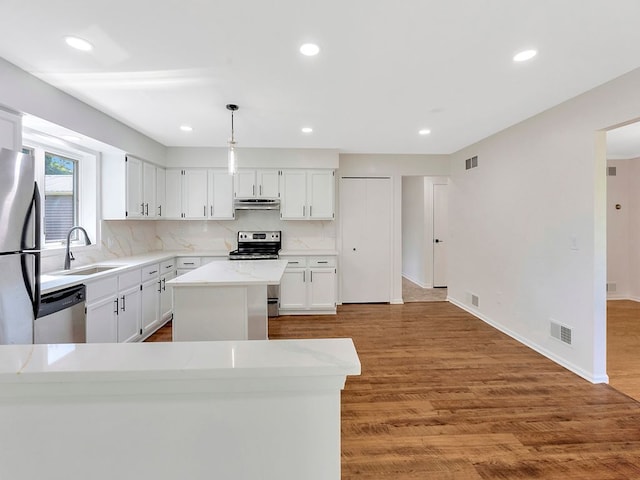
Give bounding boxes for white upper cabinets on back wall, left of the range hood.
[165,168,235,220]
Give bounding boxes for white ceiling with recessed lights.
[0,0,640,153]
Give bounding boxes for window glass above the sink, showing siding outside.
[43,152,78,244]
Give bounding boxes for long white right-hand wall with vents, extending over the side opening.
[448,69,640,382]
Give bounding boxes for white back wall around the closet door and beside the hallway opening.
[336,154,450,303]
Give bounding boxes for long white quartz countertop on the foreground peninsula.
[0,338,360,384]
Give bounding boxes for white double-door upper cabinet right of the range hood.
[280,169,335,220]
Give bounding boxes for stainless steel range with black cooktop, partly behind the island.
[229,231,282,317]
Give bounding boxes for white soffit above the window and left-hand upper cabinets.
[0,58,165,165]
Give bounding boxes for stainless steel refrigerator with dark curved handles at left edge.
[0,148,41,345]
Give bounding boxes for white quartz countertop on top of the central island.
[167,260,288,287]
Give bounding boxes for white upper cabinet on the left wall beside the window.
[102,156,164,220]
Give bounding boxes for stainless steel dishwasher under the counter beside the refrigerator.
[33,285,87,343]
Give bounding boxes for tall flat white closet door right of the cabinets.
[340,178,393,303]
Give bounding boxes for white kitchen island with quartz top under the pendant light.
[167,260,287,342]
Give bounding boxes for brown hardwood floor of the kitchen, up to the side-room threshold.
[148,302,640,480]
